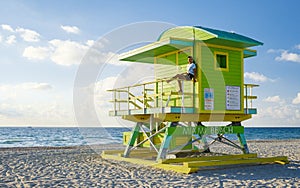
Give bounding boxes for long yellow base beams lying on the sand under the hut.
[101,150,289,174]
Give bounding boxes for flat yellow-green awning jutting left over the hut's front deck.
[119,38,194,63]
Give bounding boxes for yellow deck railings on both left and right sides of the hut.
[108,80,258,116]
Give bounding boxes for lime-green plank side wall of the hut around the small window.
[200,46,243,112]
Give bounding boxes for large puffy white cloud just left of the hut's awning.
[23,39,123,66]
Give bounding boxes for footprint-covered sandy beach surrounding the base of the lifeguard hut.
[0,140,300,187]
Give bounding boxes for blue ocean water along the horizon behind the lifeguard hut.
[0,127,300,148]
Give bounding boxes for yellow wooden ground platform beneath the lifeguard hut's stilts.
[101,148,288,174]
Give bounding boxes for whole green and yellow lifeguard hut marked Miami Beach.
[102,26,287,173]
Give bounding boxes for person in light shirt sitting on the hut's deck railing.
[167,56,197,93]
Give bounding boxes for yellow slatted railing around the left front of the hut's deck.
[107,80,195,114]
